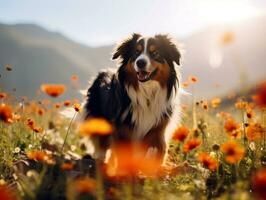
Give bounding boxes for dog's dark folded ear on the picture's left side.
[112,33,141,60]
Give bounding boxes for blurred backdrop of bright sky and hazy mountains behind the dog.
[0,0,266,98]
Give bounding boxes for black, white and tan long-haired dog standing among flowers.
[84,33,181,163]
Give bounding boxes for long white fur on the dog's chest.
[126,80,170,139]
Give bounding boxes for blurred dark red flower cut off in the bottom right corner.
[252,168,266,200]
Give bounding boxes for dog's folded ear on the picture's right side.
[155,35,181,65]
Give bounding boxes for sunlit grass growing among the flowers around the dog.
[0,85,266,199]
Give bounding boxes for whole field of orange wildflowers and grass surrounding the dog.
[0,60,266,200]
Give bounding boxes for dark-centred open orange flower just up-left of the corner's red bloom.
[221,141,245,164]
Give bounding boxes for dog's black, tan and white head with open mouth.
[112,34,180,85]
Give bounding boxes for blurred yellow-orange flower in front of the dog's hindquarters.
[79,118,113,136]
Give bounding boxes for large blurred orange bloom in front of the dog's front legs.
[106,143,162,178]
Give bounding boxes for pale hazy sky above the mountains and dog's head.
[0,0,266,46]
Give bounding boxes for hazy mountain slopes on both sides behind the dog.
[0,16,266,98]
